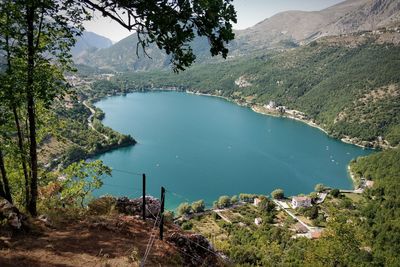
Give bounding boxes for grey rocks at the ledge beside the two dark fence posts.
[115,196,161,219]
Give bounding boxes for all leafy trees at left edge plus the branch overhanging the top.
[0,0,236,216]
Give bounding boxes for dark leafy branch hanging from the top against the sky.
[81,0,237,71]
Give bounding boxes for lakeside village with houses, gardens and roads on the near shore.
[174,178,374,243]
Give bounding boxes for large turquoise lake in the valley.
[96,92,372,209]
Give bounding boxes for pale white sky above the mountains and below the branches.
[85,0,343,42]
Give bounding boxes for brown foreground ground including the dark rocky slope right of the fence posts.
[0,199,224,267]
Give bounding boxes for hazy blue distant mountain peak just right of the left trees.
[71,31,113,59]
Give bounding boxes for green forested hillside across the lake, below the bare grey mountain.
[112,32,400,146]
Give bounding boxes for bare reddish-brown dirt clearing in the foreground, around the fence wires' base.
[0,215,180,267]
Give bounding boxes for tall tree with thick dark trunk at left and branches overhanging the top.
[0,0,236,216]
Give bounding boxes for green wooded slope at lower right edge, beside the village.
[351,148,400,266]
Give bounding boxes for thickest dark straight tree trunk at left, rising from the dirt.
[26,1,38,216]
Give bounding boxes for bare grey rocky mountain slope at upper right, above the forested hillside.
[237,0,400,48]
